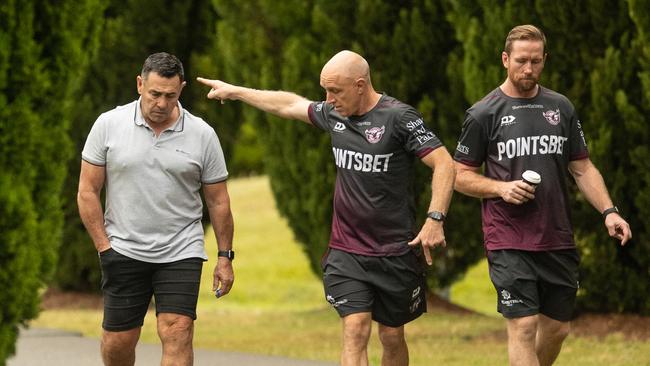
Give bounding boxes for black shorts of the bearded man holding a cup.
[487,249,580,322]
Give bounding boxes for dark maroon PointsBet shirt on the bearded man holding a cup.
[454,86,589,251]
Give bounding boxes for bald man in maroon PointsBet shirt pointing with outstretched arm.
[198,51,455,365]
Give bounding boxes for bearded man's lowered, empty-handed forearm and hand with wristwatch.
[569,158,632,245]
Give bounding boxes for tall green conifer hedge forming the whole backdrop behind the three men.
[0,0,650,360]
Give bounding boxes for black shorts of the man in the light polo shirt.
[99,248,203,332]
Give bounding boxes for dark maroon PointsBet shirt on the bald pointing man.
[309,95,442,256]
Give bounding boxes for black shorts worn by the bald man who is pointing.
[323,249,427,327]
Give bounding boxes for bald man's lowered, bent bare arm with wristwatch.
[408,147,456,265]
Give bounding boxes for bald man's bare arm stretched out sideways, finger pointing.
[196,77,312,123]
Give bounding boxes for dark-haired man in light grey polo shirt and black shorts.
[78,53,234,365]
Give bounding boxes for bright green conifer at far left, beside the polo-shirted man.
[0,0,103,365]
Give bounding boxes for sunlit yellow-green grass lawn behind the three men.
[31,177,650,366]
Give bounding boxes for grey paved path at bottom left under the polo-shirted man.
[7,328,336,366]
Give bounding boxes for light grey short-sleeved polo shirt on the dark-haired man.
[81,99,228,263]
